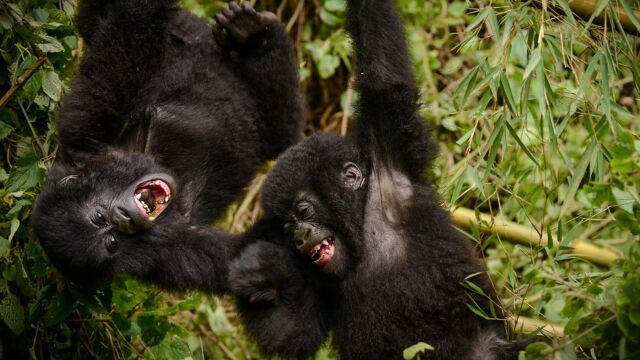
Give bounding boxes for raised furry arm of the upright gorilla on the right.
[347,0,437,181]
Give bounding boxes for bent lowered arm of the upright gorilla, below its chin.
[229,220,331,358]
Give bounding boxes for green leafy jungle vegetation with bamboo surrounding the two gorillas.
[0,0,640,359]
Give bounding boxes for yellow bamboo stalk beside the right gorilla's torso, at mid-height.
[452,207,621,267]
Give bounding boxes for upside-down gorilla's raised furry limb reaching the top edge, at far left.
[58,0,175,158]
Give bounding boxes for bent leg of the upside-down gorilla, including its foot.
[216,1,303,157]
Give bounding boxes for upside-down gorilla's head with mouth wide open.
[32,155,177,281]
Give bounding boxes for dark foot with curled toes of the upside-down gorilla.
[216,1,278,45]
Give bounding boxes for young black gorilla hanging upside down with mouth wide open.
[33,0,302,292]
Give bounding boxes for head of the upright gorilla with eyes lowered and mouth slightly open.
[263,134,367,277]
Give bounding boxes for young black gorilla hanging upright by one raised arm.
[229,0,518,360]
